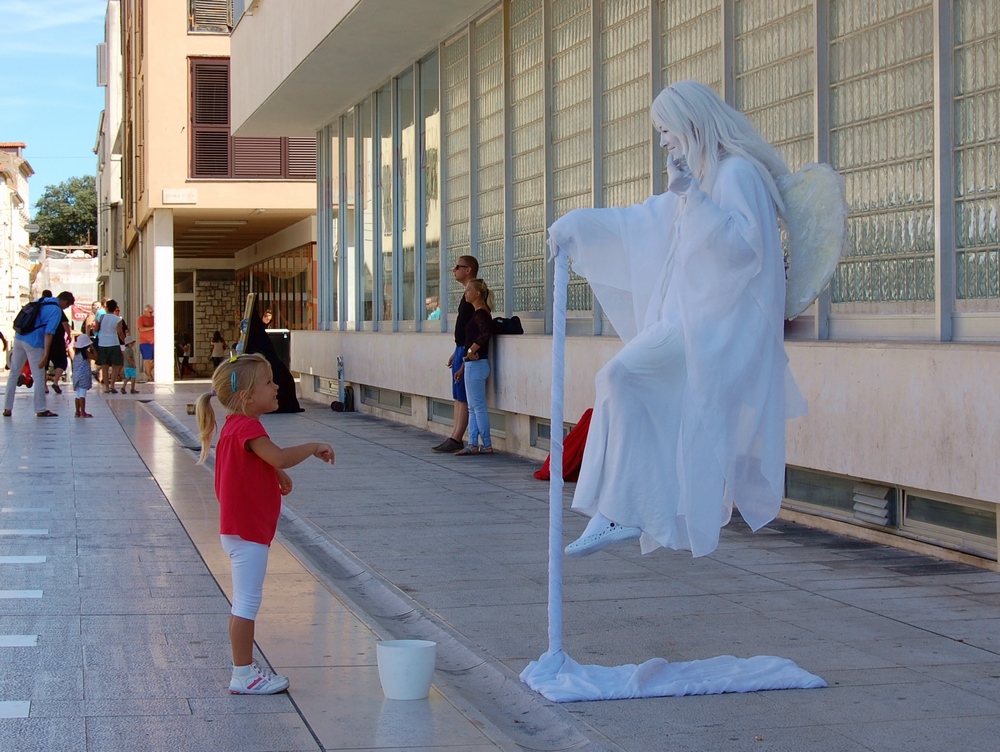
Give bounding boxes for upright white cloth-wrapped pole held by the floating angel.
[549,253,569,653]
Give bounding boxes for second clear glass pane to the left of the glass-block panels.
[397,70,417,321]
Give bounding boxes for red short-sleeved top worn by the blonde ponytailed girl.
[215,413,281,546]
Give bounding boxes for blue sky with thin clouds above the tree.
[0,0,108,215]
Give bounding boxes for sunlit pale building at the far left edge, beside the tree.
[0,141,35,341]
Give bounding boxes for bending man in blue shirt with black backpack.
[3,292,74,418]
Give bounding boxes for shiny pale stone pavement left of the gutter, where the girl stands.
[0,388,509,752]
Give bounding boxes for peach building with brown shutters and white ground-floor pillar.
[113,0,317,382]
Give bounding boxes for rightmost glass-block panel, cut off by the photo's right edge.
[954,0,1000,299]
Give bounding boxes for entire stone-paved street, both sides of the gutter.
[0,384,1000,752]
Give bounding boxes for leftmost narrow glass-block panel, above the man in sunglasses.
[441,34,471,311]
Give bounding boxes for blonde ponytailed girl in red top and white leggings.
[195,354,334,695]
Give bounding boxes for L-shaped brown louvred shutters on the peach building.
[188,58,316,180]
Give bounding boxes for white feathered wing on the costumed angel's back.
[778,163,849,319]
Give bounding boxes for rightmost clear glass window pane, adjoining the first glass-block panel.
[420,52,441,320]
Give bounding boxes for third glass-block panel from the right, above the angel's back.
[733,0,815,172]
